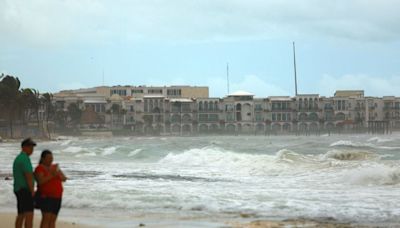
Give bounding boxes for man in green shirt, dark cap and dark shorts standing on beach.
[13,138,36,228]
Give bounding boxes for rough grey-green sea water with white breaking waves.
[0,134,400,226]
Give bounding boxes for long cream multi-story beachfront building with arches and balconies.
[54,86,400,135]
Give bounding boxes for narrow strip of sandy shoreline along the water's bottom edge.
[0,211,394,228]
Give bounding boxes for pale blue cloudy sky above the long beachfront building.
[0,0,400,97]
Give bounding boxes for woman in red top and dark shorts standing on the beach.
[35,150,67,228]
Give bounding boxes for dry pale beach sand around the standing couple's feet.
[0,212,94,228]
